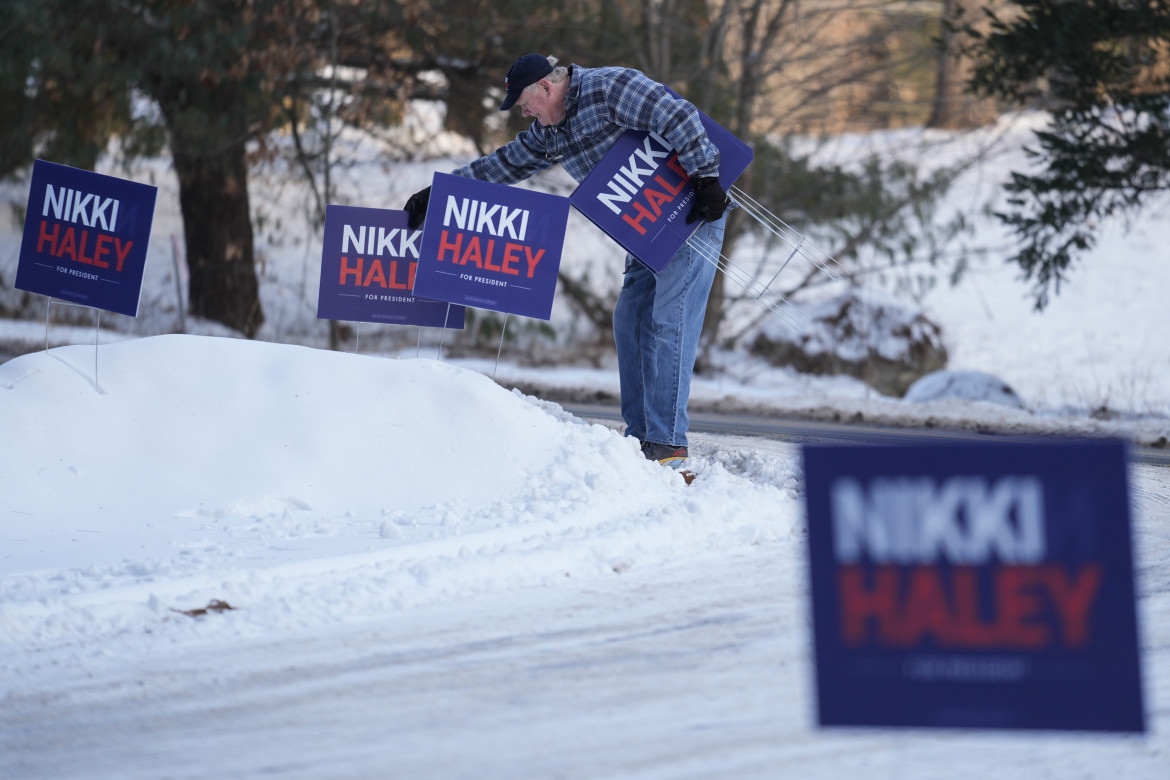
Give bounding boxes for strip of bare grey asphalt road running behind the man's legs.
[562,403,1170,467]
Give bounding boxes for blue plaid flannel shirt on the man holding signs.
[452,65,720,184]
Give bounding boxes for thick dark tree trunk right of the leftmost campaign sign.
[160,85,264,338]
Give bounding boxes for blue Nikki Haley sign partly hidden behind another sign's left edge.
[317,206,466,330]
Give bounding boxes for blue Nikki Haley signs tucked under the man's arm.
[569,99,753,271]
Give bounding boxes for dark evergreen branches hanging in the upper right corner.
[963,0,1170,309]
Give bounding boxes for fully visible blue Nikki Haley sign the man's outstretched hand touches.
[414,173,569,319]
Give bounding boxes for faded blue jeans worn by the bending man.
[613,215,727,447]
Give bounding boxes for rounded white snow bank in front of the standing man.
[0,336,799,644]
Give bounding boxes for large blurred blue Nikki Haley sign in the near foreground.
[804,441,1144,732]
